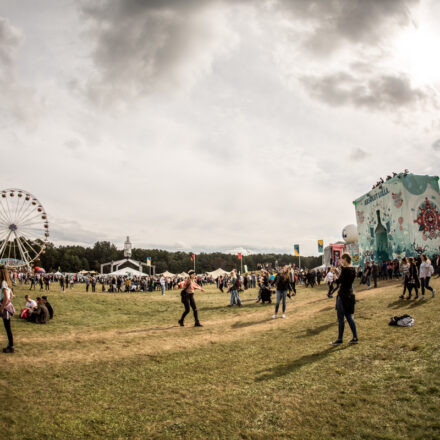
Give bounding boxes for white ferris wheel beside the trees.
[0,188,49,268]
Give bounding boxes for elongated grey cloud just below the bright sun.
[302,72,428,110]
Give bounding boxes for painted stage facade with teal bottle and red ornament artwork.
[353,174,440,264]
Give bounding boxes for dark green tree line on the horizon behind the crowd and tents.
[36,241,322,273]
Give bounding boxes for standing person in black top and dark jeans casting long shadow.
[331,254,359,345]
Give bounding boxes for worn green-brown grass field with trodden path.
[0,279,440,440]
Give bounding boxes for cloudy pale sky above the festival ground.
[0,0,440,255]
